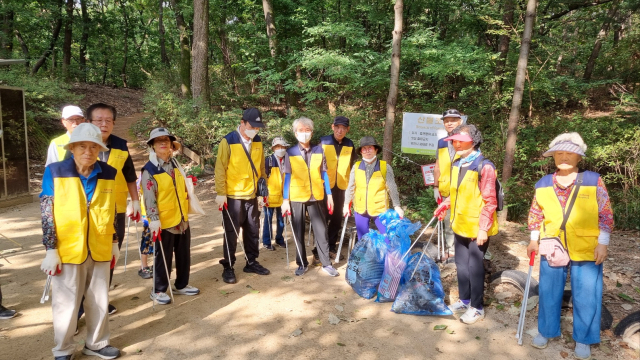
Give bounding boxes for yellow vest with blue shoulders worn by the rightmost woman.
[536,171,600,261]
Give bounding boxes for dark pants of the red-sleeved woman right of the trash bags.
[455,234,489,309]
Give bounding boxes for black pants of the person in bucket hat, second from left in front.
[153,228,191,292]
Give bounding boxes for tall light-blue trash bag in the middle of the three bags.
[376,210,421,302]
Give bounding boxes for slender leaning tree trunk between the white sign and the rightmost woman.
[500,0,538,222]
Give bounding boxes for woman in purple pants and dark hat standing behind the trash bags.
[342,136,404,240]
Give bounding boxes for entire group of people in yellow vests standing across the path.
[40,103,613,360]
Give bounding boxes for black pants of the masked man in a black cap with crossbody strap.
[220,198,260,267]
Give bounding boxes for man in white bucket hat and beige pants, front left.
[40,124,120,360]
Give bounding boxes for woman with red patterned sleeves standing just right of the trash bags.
[434,125,498,324]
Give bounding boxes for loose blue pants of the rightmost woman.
[538,256,602,345]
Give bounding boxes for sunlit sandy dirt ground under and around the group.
[0,86,640,359]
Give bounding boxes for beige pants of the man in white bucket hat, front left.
[51,256,109,357]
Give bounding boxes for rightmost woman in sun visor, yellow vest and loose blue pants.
[527,132,613,359]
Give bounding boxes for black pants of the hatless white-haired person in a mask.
[291,201,331,266]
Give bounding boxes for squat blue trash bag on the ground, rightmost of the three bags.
[391,253,453,315]
